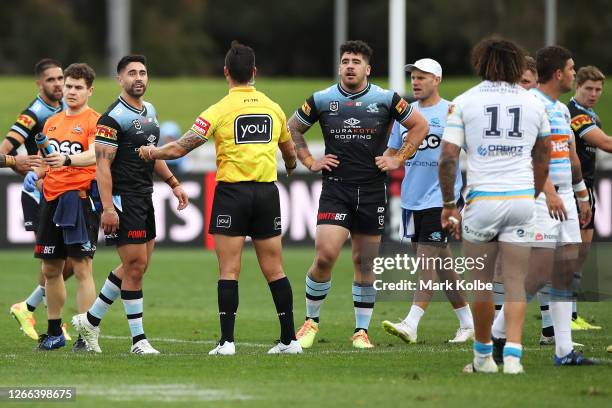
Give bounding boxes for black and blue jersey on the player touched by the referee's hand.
[96,96,159,195]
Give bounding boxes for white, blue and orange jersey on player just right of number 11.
[529,88,574,191]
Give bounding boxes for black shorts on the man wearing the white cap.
[402,207,448,246]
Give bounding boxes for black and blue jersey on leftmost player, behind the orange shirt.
[11,95,66,154]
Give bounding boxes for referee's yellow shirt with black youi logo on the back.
[191,86,291,183]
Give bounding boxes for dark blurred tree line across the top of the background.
[0,0,612,77]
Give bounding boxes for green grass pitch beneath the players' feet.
[0,248,612,407]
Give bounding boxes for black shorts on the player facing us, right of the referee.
[317,179,387,235]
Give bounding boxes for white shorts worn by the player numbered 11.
[462,193,535,243]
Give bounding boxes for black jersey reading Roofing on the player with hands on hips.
[296,84,412,184]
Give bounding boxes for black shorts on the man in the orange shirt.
[34,197,100,259]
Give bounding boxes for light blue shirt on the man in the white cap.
[387,99,463,210]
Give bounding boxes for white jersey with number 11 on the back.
[443,81,550,200]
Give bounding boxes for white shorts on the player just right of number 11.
[533,190,582,248]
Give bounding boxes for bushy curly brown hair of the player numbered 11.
[472,37,525,84]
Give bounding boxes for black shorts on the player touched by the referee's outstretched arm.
[104,194,156,246]
